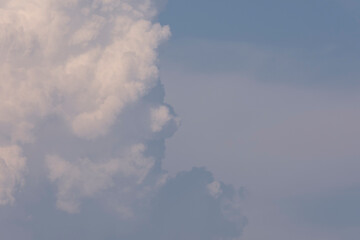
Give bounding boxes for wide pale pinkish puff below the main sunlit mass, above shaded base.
[46,144,154,213]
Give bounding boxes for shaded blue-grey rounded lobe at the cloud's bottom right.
[141,168,246,240]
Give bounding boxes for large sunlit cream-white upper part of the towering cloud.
[0,0,170,202]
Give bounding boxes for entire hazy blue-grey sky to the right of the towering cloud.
[159,0,360,240]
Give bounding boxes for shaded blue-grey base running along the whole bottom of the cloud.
[0,168,246,240]
